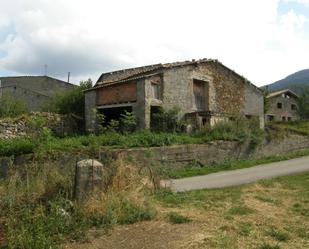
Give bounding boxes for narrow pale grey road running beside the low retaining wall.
[164,156,309,192]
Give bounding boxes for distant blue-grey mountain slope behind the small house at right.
[263,69,309,93]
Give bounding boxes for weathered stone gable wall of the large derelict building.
[141,62,264,128]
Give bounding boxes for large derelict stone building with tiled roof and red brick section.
[85,59,264,130]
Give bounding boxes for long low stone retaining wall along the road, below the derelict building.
[101,135,309,167]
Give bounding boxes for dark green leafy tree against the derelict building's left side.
[43,78,92,117]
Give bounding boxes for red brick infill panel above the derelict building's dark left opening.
[97,82,136,105]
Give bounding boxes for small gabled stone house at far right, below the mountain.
[265,89,299,122]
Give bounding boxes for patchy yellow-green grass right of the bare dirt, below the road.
[156,173,309,249]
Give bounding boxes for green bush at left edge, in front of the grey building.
[0,94,29,118]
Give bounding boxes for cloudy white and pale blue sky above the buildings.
[0,0,309,86]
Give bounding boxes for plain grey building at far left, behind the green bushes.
[0,76,76,111]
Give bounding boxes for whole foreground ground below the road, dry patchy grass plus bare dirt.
[66,173,309,249]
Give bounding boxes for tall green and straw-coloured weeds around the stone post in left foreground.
[0,161,155,249]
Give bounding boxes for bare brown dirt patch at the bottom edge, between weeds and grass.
[65,221,201,249]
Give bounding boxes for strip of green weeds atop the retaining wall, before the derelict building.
[0,113,264,156]
